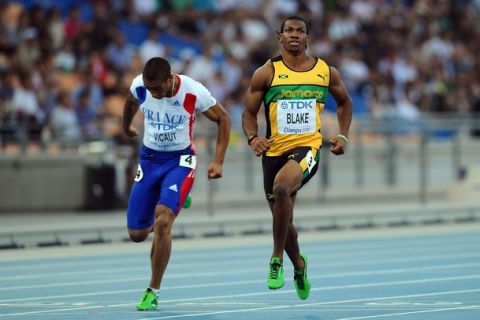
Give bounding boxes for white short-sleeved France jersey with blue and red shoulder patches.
[130,75,216,151]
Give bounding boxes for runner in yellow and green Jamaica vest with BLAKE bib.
[242,16,352,300]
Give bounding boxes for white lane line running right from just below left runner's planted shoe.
[136,289,480,320]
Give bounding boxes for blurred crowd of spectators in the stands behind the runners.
[0,0,480,150]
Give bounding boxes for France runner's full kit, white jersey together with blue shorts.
[127,75,216,230]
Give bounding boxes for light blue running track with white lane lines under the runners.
[0,231,480,320]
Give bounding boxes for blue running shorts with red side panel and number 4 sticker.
[127,146,197,230]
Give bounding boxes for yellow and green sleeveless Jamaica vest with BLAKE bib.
[263,56,330,156]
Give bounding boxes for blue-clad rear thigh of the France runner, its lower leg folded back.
[127,160,163,230]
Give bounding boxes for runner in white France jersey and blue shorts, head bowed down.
[123,58,230,311]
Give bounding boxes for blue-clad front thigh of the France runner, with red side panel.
[158,163,195,215]
